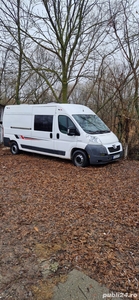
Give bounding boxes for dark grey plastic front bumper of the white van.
[85,145,123,165]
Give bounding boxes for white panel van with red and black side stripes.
[3,103,123,167]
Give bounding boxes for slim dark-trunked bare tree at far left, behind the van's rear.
[0,0,32,104]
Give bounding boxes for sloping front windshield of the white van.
[73,114,110,134]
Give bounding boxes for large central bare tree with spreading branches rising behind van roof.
[17,0,107,102]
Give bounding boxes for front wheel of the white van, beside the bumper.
[72,150,89,167]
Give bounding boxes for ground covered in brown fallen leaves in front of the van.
[0,147,139,300]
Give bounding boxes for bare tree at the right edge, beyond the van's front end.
[106,0,139,157]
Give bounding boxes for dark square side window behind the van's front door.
[34,115,53,131]
